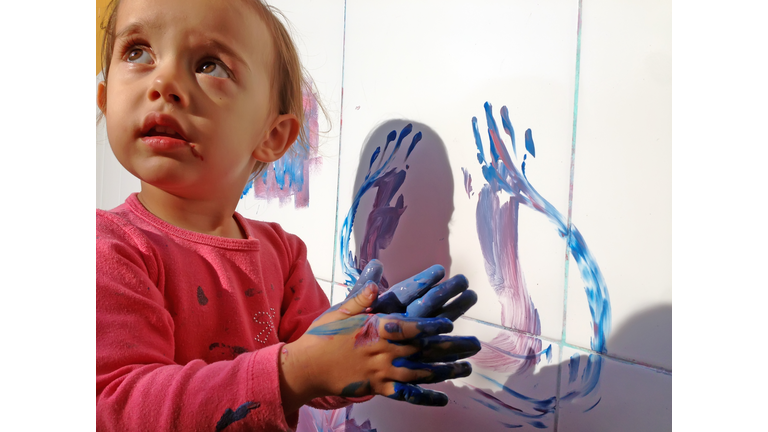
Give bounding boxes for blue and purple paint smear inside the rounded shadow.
[339,123,422,289]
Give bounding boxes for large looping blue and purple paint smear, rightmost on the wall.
[462,102,611,428]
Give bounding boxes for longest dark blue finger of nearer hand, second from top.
[402,336,482,363]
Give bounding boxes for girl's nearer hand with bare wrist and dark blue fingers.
[280,282,480,412]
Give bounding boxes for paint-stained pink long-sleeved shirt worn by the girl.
[96,194,370,431]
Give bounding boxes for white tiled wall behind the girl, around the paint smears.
[97,0,672,432]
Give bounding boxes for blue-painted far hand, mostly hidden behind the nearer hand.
[347,260,477,321]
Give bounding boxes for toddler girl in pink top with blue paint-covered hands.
[96,0,479,431]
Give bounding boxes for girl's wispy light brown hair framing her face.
[101,0,327,181]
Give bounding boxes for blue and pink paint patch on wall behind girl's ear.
[240,91,322,208]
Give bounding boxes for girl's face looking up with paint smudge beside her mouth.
[98,0,276,199]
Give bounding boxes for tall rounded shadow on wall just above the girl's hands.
[352,119,453,284]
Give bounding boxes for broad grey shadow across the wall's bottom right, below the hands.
[351,305,672,432]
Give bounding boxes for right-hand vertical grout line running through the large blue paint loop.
[554,0,582,432]
